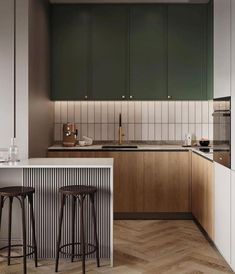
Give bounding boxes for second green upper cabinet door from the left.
[91,4,129,100]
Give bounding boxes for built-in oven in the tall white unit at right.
[213,97,231,168]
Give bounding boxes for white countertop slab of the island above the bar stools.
[0,158,113,168]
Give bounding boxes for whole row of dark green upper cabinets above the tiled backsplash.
[51,0,213,100]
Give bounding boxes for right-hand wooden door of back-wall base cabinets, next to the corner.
[143,151,191,212]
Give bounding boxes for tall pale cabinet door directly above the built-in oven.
[214,0,231,98]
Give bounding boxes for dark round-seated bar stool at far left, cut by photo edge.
[0,186,37,274]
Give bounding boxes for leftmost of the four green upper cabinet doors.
[51,5,90,100]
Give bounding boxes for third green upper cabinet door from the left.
[130,5,167,100]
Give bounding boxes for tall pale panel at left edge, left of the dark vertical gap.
[0,0,14,148]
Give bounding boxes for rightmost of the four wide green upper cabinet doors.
[168,4,207,100]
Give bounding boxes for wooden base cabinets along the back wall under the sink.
[48,151,191,213]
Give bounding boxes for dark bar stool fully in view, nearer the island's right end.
[55,185,100,273]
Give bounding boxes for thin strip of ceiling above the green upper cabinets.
[50,0,209,4]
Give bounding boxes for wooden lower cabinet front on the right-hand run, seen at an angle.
[192,153,214,240]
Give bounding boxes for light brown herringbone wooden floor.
[0,221,233,274]
